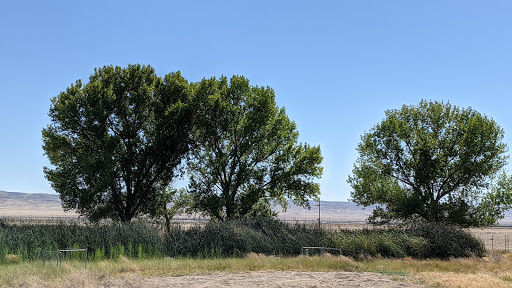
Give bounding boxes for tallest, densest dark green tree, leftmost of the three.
[42,65,195,221]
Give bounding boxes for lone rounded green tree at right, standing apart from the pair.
[348,100,512,226]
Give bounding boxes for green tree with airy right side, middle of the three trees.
[188,76,322,220]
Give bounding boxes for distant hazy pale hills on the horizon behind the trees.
[0,190,512,226]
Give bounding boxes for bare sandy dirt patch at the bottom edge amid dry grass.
[93,271,424,288]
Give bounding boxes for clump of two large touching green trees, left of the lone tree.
[42,65,322,222]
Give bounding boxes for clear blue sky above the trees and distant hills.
[0,0,512,201]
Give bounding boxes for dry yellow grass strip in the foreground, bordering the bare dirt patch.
[0,252,512,288]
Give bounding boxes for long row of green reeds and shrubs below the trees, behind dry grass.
[0,218,485,262]
